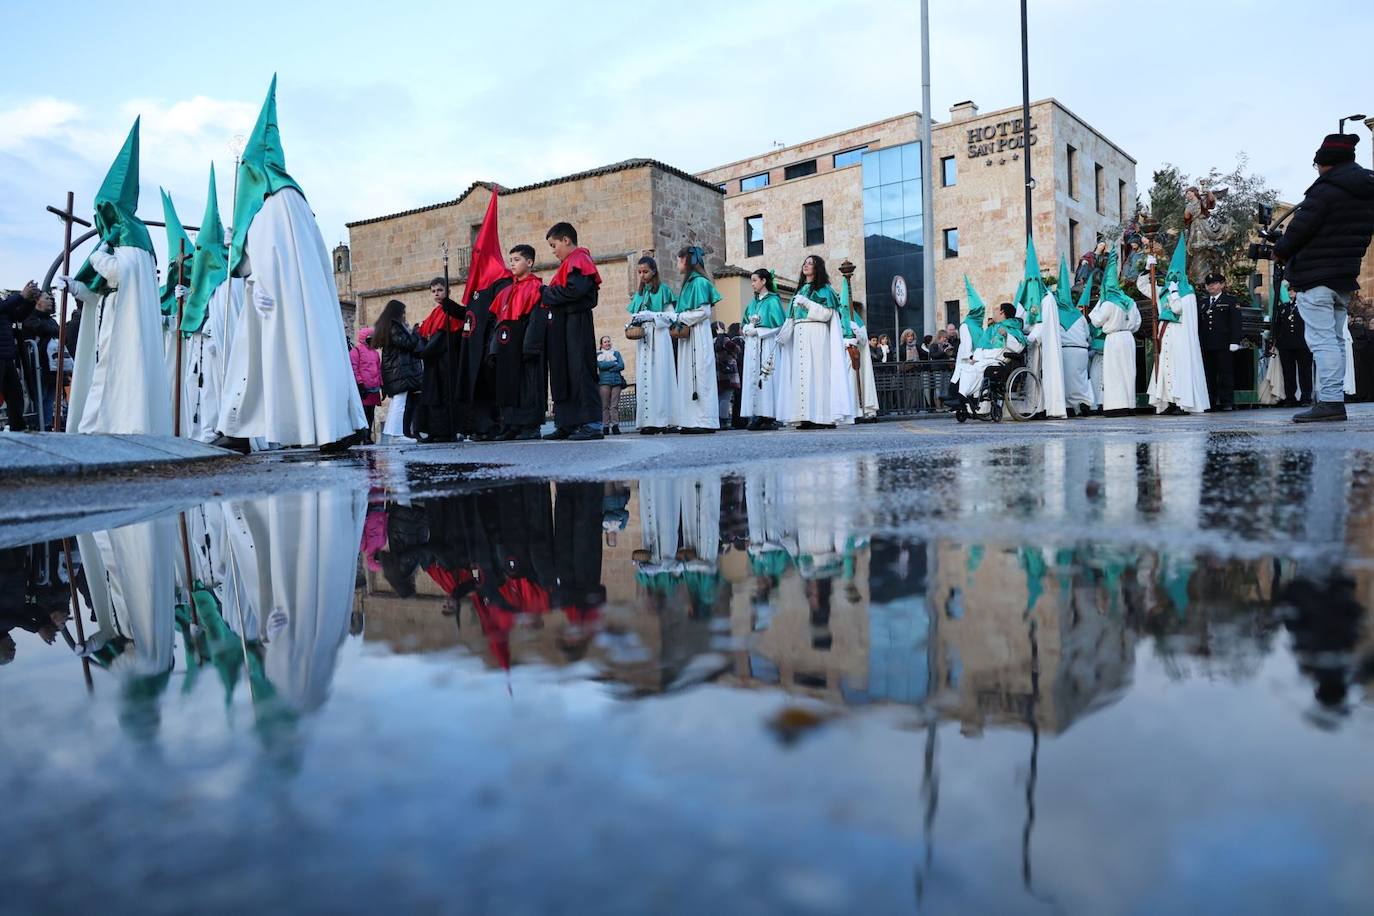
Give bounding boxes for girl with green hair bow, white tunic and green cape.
[673,244,720,434]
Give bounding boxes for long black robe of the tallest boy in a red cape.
[544,271,602,430]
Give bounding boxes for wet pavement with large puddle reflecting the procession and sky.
[0,417,1374,913]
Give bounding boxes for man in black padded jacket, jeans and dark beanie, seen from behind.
[1274,133,1374,423]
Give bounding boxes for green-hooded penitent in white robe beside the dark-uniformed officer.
[1138,239,1210,413]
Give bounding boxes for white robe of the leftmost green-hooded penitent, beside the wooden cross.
[66,247,172,435]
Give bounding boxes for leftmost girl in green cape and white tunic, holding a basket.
[629,255,677,435]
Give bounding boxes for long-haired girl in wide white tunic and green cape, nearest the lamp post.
[787,254,853,430]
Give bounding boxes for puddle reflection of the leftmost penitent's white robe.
[77,515,180,677]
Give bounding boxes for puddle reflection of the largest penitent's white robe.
[236,490,367,711]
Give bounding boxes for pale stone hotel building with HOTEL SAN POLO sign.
[699,99,1136,341]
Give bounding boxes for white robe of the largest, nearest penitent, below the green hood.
[220,188,367,445]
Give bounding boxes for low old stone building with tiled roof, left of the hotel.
[334,159,725,379]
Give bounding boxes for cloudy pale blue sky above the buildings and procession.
[0,0,1374,281]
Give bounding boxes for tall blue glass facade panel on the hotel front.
[855,141,925,341]
